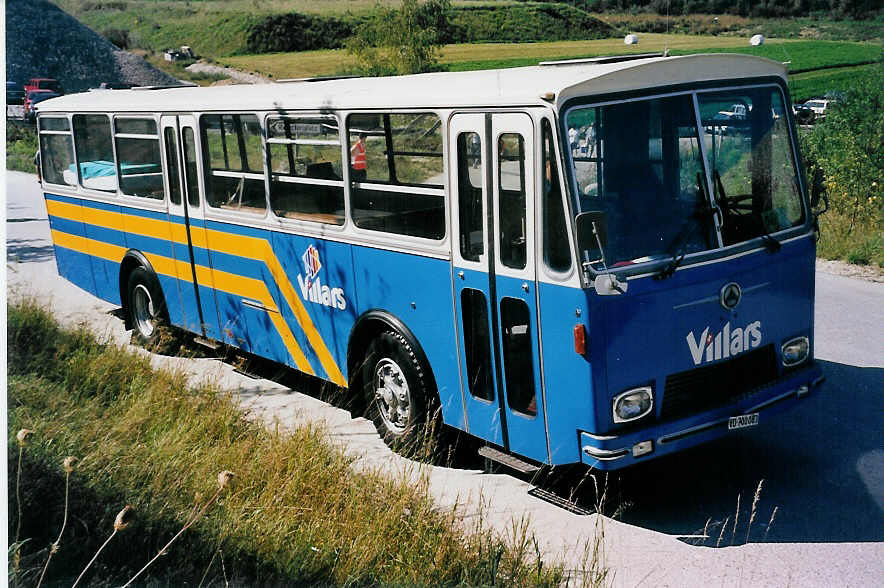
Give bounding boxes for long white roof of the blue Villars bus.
[39,53,786,113]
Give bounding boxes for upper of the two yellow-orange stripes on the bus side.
[46,200,347,387]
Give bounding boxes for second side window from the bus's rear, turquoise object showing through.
[74,114,117,192]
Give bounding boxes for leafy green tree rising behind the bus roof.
[347,0,451,76]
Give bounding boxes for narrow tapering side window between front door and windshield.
[541,118,571,272]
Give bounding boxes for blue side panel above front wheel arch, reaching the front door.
[353,246,465,429]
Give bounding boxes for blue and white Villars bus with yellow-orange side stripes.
[38,54,821,470]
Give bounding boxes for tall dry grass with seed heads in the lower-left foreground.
[8,301,566,585]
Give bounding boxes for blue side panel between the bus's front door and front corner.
[539,282,596,465]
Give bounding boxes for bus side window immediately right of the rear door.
[200,114,267,214]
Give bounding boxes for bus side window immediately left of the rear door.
[114,117,165,200]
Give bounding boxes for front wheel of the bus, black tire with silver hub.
[361,331,439,453]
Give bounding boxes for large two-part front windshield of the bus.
[565,86,804,267]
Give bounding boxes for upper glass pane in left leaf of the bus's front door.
[457,133,485,261]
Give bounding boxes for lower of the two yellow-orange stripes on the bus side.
[52,229,316,375]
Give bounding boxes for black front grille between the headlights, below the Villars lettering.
[660,345,777,420]
